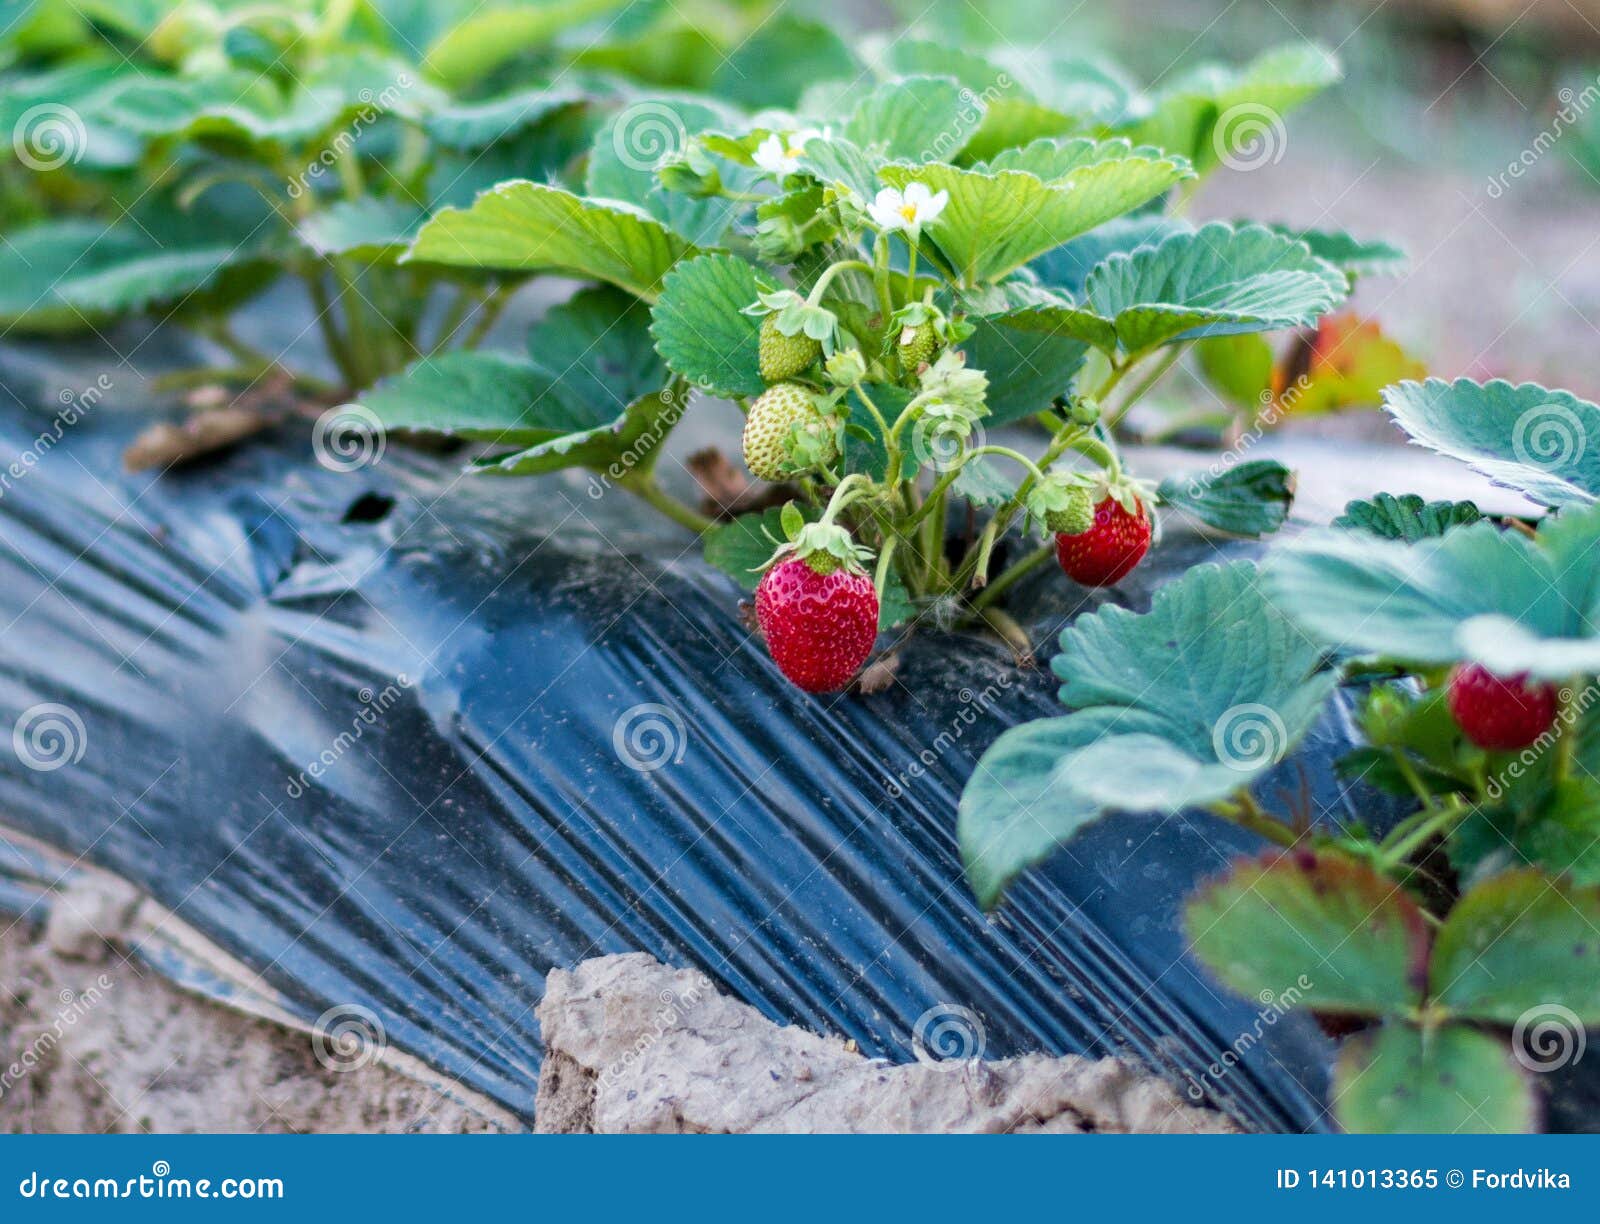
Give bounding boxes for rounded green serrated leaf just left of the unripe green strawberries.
[650,254,778,397]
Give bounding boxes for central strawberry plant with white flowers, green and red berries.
[362,38,1362,690]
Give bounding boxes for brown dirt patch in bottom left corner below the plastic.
[0,890,499,1133]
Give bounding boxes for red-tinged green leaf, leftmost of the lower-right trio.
[1184,851,1429,1016]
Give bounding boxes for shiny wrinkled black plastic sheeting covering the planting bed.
[0,339,1433,1130]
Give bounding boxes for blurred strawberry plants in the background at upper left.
[0,0,774,395]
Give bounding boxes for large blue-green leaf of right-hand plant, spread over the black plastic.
[957,563,1334,907]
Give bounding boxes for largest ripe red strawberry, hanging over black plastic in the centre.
[755,554,878,693]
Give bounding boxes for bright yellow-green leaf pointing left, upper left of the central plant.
[403,179,694,301]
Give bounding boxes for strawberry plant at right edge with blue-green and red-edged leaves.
[960,379,1600,1131]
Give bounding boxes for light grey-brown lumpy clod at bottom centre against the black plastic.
[538,952,1237,1133]
